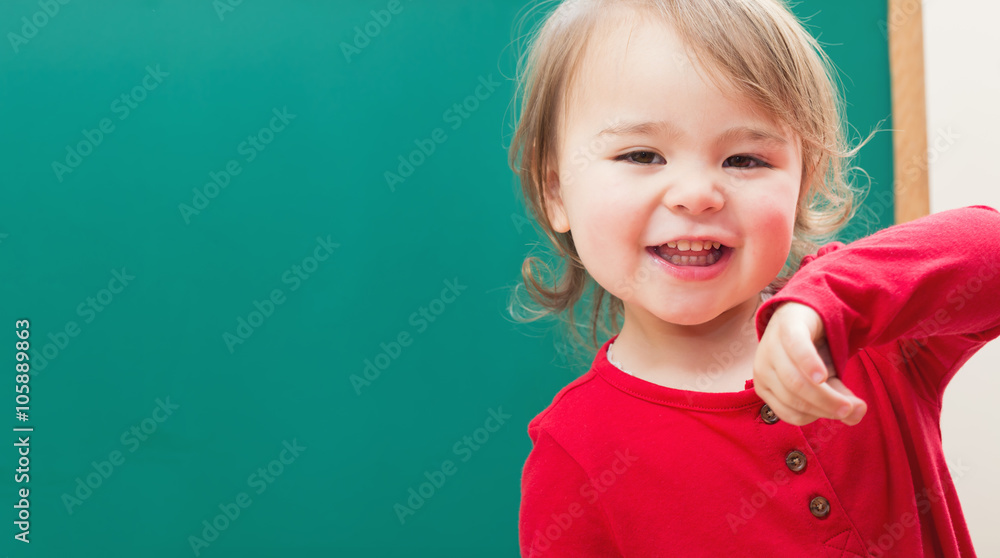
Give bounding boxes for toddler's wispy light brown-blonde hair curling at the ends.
[508,0,874,363]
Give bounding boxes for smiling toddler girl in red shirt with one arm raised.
[511,0,1000,558]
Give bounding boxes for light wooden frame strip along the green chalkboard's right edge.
[886,0,930,223]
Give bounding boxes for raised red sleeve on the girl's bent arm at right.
[756,205,1000,401]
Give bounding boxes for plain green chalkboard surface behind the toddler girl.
[0,0,892,558]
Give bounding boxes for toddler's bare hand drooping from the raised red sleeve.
[753,302,868,426]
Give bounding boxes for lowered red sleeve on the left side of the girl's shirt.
[518,427,621,558]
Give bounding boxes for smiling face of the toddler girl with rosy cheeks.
[549,17,802,325]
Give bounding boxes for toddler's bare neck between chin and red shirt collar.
[612,296,761,392]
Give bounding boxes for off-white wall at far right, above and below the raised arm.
[923,0,1000,556]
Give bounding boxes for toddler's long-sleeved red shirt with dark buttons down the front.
[519,206,1000,558]
